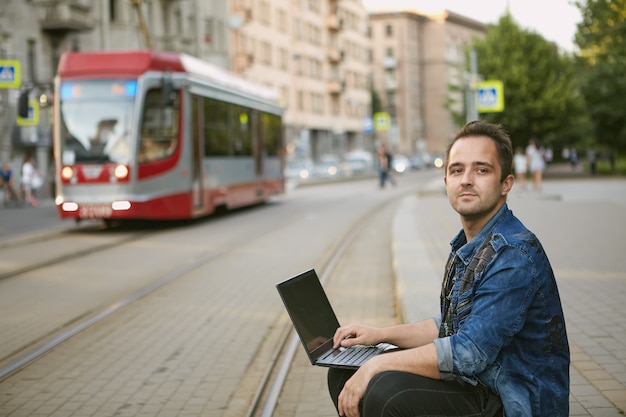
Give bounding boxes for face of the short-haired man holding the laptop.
[444,136,513,223]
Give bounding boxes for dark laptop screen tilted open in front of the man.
[276,269,339,358]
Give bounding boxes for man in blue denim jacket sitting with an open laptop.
[328,121,569,417]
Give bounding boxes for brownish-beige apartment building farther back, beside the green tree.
[369,10,486,154]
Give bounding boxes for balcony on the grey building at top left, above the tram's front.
[36,0,94,33]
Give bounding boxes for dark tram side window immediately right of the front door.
[204,98,229,156]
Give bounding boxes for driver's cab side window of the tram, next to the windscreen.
[139,88,180,162]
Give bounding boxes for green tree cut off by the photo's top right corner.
[576,0,626,151]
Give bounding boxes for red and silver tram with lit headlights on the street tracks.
[54,50,284,222]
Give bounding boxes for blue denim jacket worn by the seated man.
[435,204,570,417]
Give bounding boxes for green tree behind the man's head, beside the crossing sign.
[454,13,588,153]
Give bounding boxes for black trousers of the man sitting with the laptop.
[328,368,503,417]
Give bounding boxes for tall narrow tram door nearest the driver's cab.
[191,96,204,212]
